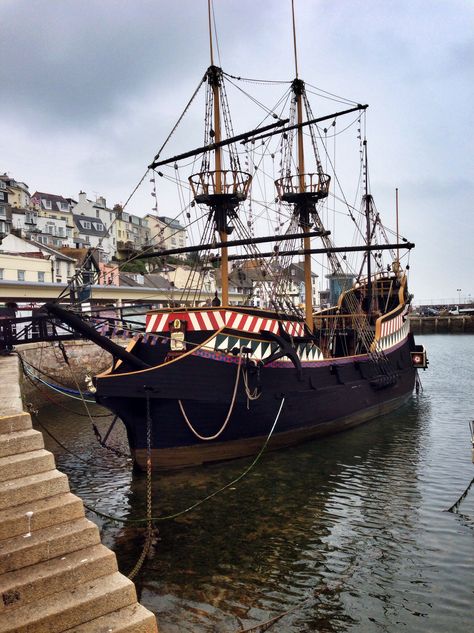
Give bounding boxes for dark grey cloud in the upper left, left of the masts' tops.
[0,0,276,127]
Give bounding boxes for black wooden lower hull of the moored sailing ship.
[96,336,416,470]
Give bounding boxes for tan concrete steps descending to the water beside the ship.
[0,356,158,633]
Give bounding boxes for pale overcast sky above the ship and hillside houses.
[0,0,474,303]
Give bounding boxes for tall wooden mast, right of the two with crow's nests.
[291,0,314,332]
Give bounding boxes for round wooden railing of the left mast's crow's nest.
[189,169,252,200]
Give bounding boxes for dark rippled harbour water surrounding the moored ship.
[37,335,474,633]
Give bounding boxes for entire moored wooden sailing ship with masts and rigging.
[47,2,427,470]
